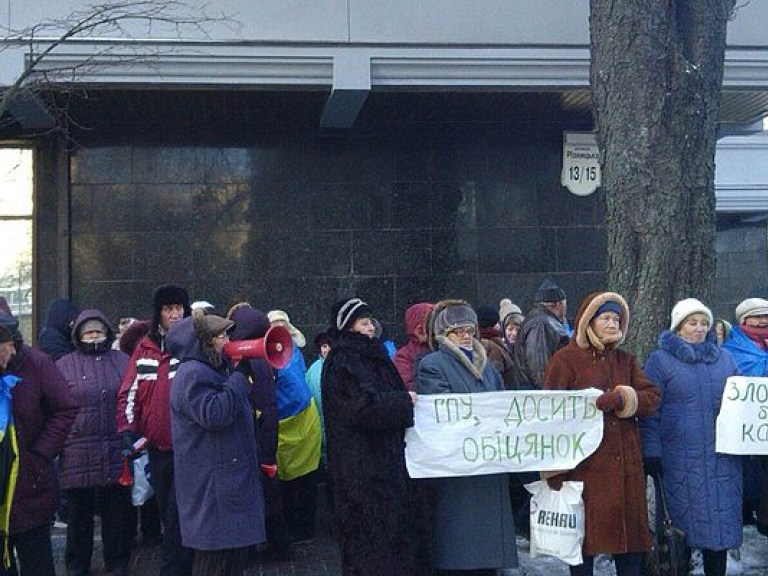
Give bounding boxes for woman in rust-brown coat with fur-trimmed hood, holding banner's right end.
[544,292,661,576]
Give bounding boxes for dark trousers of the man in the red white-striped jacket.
[149,450,192,576]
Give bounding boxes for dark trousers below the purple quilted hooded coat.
[64,484,132,573]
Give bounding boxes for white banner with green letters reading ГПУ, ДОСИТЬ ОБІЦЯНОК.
[405,388,603,478]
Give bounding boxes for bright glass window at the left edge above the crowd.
[0,148,33,342]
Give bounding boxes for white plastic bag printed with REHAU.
[525,480,584,566]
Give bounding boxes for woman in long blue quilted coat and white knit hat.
[643,298,742,576]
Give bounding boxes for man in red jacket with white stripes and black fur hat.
[117,284,192,576]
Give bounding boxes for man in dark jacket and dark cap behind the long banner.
[514,279,569,390]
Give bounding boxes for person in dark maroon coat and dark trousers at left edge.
[0,312,76,576]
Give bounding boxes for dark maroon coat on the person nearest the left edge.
[6,342,76,534]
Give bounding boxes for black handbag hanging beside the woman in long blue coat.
[645,474,690,576]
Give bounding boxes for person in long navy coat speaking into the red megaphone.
[165,310,266,576]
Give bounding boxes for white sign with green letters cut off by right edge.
[716,376,768,455]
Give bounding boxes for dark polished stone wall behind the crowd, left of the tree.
[36,90,605,343]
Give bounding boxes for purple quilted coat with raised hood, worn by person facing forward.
[56,310,130,489]
